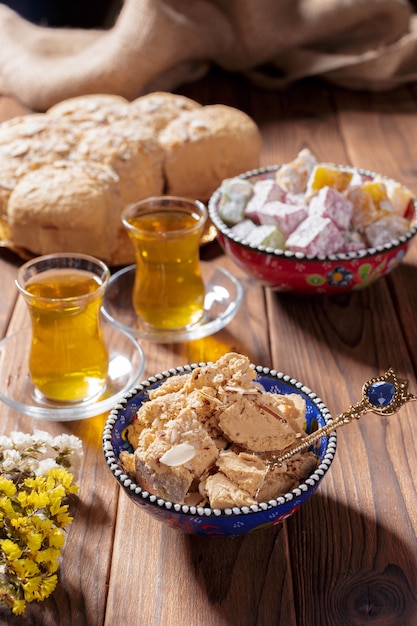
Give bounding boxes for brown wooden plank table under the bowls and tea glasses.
[0,72,417,626]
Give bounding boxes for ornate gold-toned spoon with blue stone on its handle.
[268,368,417,468]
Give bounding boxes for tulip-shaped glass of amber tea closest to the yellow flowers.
[16,254,110,403]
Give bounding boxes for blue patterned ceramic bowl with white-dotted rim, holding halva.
[103,363,336,536]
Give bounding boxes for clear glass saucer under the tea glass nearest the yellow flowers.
[0,323,145,422]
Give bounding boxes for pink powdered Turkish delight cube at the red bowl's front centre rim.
[286,215,344,256]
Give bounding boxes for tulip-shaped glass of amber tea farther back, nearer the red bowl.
[122,196,207,330]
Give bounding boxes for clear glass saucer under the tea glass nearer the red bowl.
[102,262,243,343]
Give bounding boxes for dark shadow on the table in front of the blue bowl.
[184,494,417,626]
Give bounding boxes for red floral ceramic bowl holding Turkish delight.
[209,165,417,294]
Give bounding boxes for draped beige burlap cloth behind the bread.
[0,0,417,110]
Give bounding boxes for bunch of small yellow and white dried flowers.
[0,430,83,615]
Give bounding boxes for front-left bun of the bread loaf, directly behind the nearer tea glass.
[8,161,119,258]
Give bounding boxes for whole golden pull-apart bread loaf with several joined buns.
[0,92,261,266]
